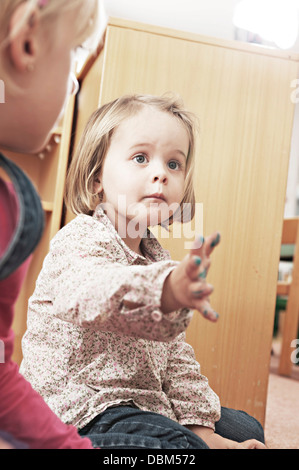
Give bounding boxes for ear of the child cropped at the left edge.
[9,2,40,72]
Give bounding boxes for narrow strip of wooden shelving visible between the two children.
[2,93,75,364]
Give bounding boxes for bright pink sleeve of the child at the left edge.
[0,208,92,449]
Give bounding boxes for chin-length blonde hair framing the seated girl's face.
[65,95,196,223]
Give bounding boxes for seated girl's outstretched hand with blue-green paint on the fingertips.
[161,232,220,322]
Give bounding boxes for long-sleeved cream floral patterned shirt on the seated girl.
[20,207,220,429]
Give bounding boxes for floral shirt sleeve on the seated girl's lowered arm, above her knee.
[163,333,221,429]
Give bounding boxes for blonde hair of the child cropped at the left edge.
[0,0,99,83]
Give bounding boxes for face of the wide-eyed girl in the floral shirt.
[97,105,189,238]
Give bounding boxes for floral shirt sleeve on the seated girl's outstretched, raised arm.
[36,220,192,341]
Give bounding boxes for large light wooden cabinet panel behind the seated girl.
[100,20,298,422]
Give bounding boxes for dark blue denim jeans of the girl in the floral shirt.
[80,406,264,449]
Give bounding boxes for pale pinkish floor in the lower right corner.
[265,340,299,449]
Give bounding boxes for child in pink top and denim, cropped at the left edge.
[0,0,98,448]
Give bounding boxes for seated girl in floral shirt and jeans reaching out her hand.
[22,95,264,449]
